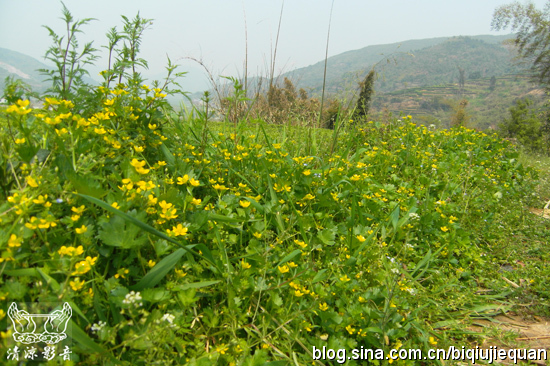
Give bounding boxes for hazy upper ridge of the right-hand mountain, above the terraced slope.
[281,35,521,94]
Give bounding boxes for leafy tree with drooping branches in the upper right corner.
[491,1,550,88]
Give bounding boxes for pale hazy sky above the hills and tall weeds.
[0,0,546,90]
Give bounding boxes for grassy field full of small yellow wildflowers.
[0,86,550,365]
